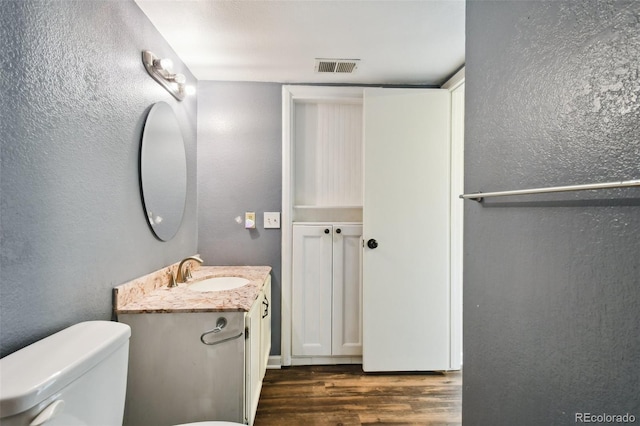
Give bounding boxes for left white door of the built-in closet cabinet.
[291,225,332,356]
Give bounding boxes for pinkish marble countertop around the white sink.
[114,265,271,314]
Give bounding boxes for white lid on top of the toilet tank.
[0,321,131,418]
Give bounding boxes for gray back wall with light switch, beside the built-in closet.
[198,81,282,354]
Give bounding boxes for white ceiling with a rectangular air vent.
[135,0,465,85]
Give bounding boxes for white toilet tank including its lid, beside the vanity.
[0,321,131,426]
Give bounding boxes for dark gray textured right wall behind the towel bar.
[463,1,640,426]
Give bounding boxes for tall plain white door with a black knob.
[363,88,450,371]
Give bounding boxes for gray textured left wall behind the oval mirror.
[0,0,197,356]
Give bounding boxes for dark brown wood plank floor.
[255,365,462,426]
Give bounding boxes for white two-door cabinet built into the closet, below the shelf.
[292,223,362,363]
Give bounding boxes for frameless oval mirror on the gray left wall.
[140,102,187,241]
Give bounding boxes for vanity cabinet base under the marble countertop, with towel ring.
[117,275,271,426]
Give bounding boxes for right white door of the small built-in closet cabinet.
[332,225,362,355]
